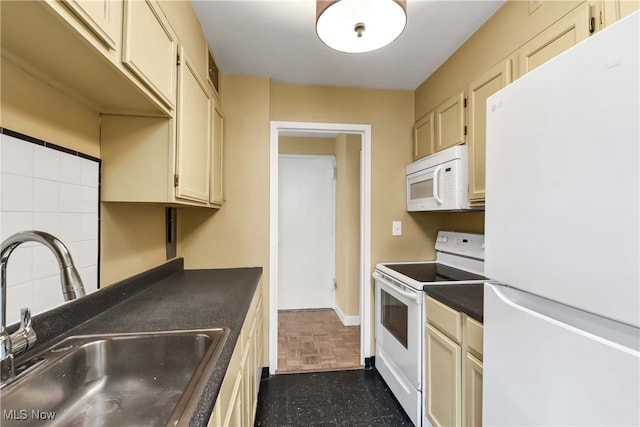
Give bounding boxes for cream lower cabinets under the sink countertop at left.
[208,286,264,427]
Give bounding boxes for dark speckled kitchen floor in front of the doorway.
[255,369,413,427]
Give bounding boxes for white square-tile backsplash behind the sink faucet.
[0,133,100,324]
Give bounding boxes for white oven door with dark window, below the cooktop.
[374,272,423,390]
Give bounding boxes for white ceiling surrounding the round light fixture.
[192,0,504,90]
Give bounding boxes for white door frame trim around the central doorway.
[269,121,372,375]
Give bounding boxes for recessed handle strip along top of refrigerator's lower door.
[487,284,640,357]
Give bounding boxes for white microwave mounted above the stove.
[407,145,471,212]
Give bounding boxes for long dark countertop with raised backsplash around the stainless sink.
[11,259,262,426]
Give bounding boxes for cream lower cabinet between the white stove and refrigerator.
[424,297,482,427]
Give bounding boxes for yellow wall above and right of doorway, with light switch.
[271,83,442,354]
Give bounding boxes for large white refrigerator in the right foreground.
[483,13,640,426]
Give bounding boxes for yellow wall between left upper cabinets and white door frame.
[178,75,270,270]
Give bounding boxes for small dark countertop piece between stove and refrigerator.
[422,283,484,323]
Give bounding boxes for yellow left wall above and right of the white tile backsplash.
[0,59,170,286]
